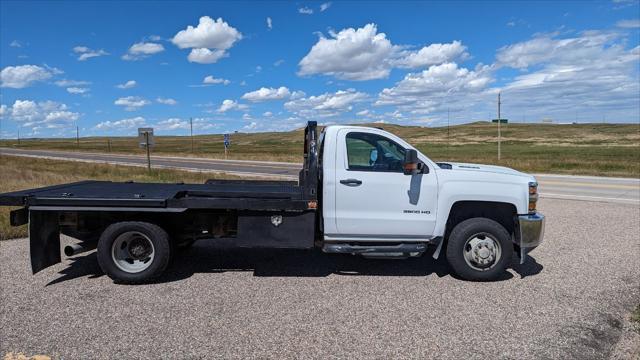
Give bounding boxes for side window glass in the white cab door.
[346,132,405,172]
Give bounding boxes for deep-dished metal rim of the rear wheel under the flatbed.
[111,231,155,274]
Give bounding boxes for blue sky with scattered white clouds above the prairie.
[0,0,640,138]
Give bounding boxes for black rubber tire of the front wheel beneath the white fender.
[447,218,513,281]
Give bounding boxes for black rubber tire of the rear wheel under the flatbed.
[98,221,171,284]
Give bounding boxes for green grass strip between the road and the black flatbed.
[0,156,242,240]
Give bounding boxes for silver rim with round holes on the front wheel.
[462,233,502,271]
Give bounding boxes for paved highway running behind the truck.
[0,148,640,205]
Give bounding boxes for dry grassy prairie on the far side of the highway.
[0,122,640,177]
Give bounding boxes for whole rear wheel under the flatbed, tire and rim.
[98,221,171,284]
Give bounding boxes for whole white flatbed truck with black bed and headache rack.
[0,122,544,283]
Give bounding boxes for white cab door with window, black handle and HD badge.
[335,129,436,240]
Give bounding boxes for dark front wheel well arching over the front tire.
[445,201,518,239]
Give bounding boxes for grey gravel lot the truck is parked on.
[0,199,640,359]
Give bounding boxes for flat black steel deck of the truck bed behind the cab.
[0,180,308,211]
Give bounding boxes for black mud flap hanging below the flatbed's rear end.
[29,210,61,274]
